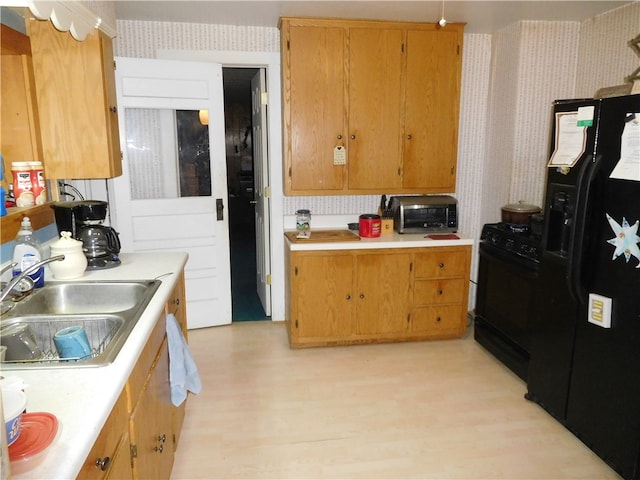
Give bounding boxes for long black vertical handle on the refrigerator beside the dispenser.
[567,155,602,303]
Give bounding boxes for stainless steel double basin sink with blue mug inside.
[0,280,161,370]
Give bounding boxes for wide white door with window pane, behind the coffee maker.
[110,57,231,328]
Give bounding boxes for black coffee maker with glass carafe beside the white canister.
[51,200,120,270]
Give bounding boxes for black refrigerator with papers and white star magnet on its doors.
[526,95,640,479]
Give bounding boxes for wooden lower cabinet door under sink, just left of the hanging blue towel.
[131,339,174,479]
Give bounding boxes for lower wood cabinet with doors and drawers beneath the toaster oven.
[286,246,471,347]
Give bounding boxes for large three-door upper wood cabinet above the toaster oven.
[280,18,464,195]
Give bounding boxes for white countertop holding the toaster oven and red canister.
[286,229,473,251]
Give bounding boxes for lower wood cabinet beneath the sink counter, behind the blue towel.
[78,274,186,480]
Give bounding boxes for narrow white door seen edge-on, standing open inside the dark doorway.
[251,68,271,316]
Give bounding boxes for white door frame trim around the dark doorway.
[156,49,285,321]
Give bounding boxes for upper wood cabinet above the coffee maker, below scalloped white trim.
[27,20,122,179]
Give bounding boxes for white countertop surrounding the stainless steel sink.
[2,252,187,479]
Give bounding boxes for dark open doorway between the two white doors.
[222,68,269,322]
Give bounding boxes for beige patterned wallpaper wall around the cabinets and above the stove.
[98,2,640,312]
